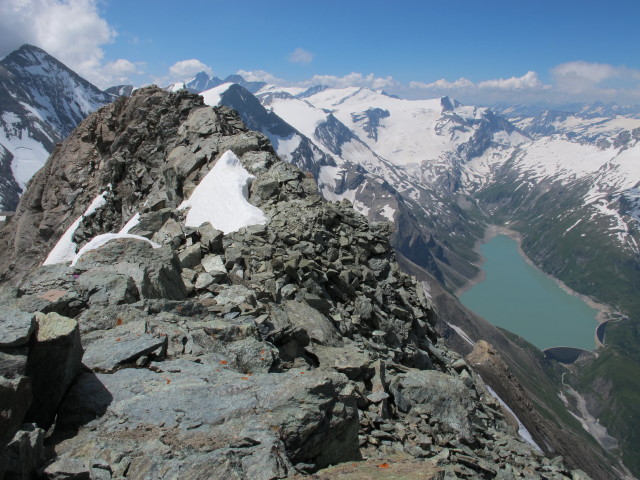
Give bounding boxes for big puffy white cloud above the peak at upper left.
[0,0,116,81]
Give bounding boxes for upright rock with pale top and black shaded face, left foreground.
[27,313,82,428]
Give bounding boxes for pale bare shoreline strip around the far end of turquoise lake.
[454,225,614,324]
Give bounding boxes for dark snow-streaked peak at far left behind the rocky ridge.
[0,45,114,210]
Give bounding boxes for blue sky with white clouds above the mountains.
[0,0,640,103]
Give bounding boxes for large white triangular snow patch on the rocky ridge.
[178,150,267,234]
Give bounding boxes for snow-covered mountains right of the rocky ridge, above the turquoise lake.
[190,76,640,318]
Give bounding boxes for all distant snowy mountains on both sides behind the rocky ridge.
[0,45,640,476]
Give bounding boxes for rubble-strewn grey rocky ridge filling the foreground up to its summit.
[0,87,588,480]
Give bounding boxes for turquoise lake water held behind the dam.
[460,235,598,350]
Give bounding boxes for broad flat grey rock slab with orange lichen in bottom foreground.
[56,360,358,479]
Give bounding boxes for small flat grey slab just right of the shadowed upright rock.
[82,331,167,373]
